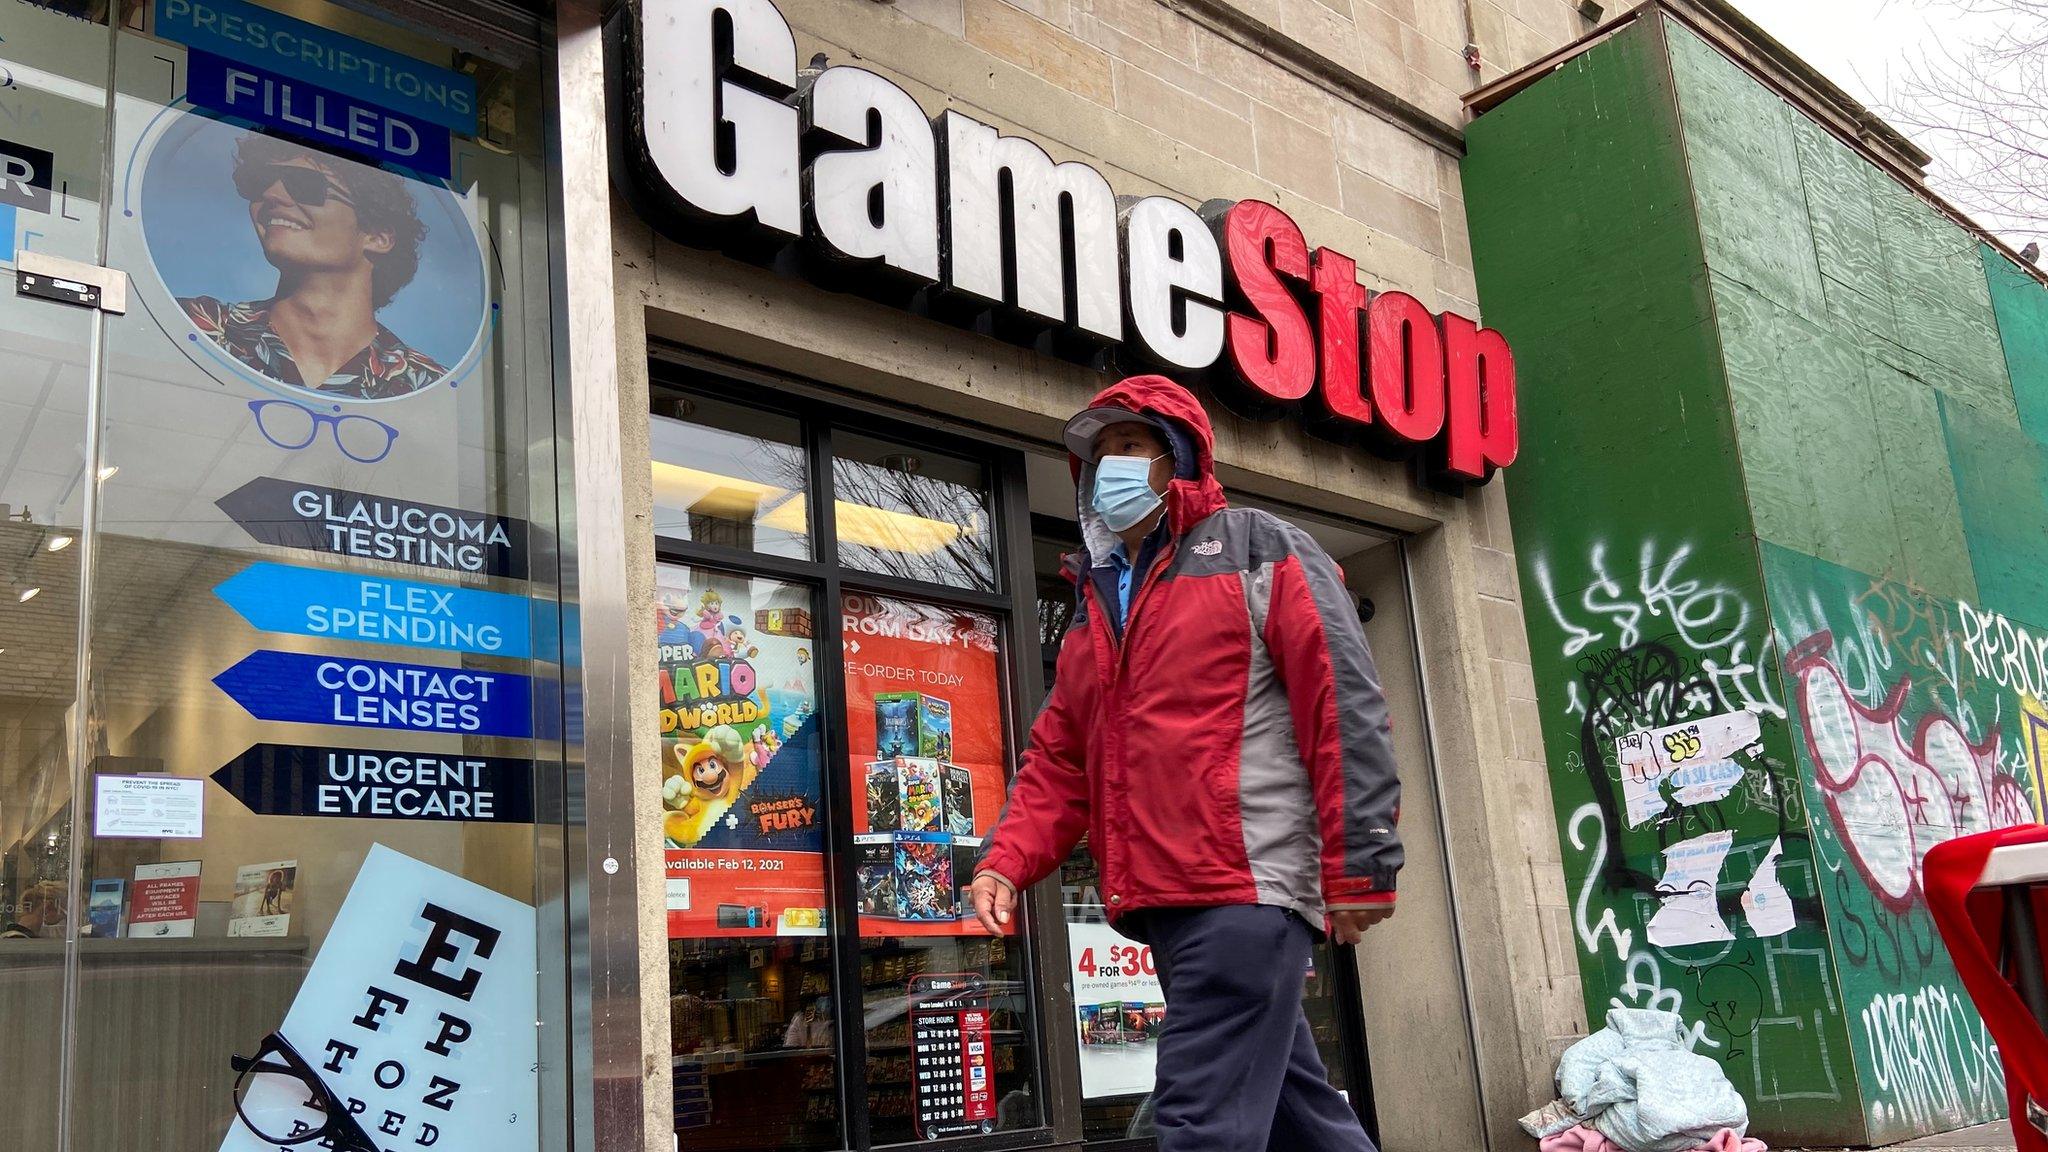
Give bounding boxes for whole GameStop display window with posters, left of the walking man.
[649,356,1049,1150]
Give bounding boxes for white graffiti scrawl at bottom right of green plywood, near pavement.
[1864,986,2005,1132]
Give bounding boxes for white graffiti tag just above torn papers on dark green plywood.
[1532,541,1784,717]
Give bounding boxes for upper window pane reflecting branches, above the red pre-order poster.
[831,433,995,590]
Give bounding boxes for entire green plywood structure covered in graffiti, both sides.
[1464,16,2048,1144]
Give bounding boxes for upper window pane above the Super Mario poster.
[649,389,811,560]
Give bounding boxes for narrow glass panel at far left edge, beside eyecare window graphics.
[0,0,113,1148]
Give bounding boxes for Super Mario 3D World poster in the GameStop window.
[655,568,829,939]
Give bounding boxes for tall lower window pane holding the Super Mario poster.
[655,561,842,1148]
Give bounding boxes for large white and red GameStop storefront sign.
[623,0,1518,486]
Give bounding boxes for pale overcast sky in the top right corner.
[1731,0,2032,246]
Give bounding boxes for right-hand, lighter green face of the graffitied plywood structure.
[1671,11,2048,1142]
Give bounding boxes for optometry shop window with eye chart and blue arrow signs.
[0,0,571,1152]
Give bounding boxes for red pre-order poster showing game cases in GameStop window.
[840,592,1006,937]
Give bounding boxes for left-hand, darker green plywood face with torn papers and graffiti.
[1464,23,1862,1144]
